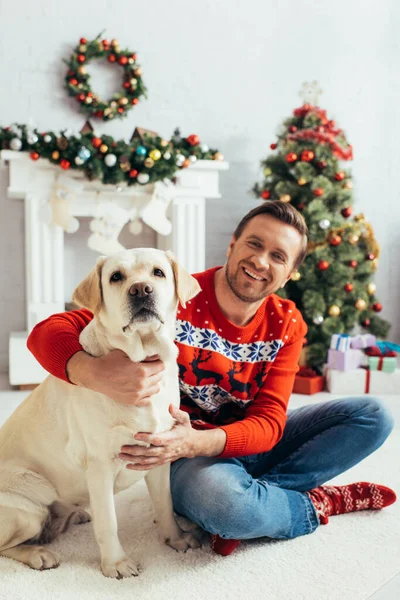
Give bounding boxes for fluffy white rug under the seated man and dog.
[0,395,400,600]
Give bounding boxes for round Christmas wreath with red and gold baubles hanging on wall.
[65,36,146,121]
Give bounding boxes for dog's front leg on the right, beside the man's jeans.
[145,463,200,552]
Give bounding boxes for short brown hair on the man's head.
[233,200,308,271]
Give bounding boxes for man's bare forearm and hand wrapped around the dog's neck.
[67,350,165,406]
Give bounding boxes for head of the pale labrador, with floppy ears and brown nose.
[72,248,200,334]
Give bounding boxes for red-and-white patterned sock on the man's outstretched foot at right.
[307,481,396,525]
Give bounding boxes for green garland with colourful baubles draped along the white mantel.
[0,121,224,185]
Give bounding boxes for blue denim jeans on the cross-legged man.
[171,396,393,539]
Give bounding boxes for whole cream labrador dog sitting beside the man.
[0,248,200,578]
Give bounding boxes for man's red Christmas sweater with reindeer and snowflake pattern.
[28,267,307,457]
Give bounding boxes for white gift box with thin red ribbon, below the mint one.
[325,368,400,396]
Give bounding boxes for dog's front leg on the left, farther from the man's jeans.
[86,461,139,579]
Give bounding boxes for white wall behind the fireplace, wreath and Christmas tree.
[0,0,400,371]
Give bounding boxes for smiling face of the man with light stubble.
[226,215,302,303]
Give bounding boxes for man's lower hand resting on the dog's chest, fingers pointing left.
[119,404,226,471]
